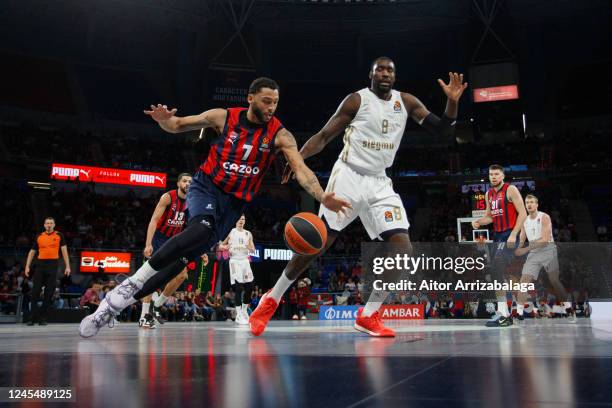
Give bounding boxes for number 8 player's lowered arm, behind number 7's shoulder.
[300,93,361,159]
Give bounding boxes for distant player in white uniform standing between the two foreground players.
[219,214,255,325]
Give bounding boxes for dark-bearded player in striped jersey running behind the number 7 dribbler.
[138,173,192,329]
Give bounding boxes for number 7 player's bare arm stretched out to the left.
[144,104,227,133]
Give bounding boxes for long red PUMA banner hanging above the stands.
[51,163,167,188]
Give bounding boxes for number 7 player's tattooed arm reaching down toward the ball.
[275,129,351,212]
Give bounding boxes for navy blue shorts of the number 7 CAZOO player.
[187,171,247,249]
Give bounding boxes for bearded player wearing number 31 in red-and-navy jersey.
[472,164,527,327]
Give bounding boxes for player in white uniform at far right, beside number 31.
[514,194,574,320]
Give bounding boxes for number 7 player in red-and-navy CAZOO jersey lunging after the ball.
[79,78,350,337]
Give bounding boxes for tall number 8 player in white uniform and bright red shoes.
[249,57,467,337]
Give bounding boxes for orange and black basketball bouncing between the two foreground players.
[285,212,327,255]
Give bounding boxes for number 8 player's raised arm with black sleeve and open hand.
[402,72,467,143]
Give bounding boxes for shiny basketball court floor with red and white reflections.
[0,319,612,408]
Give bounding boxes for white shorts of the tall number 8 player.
[319,160,410,239]
